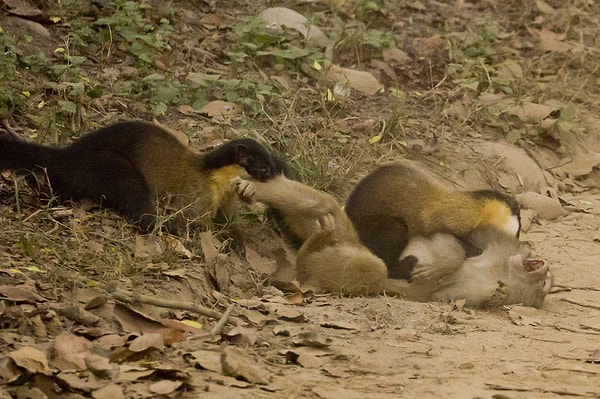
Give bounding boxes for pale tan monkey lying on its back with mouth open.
[232,176,552,307]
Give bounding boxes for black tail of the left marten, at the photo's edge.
[0,135,58,171]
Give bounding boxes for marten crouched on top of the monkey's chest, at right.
[345,161,520,278]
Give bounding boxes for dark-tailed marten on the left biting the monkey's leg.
[0,121,281,241]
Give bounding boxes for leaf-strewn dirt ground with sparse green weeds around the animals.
[0,0,600,399]
